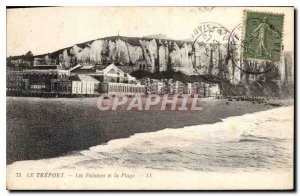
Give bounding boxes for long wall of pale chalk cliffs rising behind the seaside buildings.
[8,36,293,87]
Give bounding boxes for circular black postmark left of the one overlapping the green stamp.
[193,23,237,83]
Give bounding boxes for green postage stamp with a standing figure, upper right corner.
[242,10,284,62]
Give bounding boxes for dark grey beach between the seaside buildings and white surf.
[6,97,291,164]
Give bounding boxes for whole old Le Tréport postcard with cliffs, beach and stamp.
[6,7,295,190]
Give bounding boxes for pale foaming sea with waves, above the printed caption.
[7,106,294,173]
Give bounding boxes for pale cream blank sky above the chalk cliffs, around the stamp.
[6,7,294,56]
